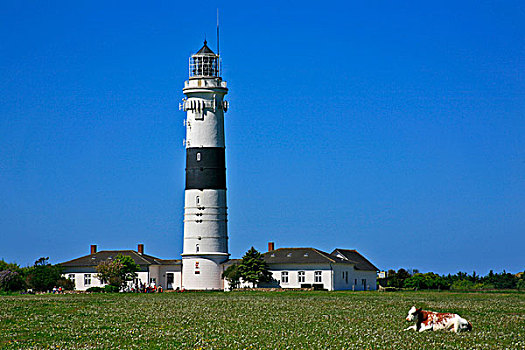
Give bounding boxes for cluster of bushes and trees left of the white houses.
[0,258,75,292]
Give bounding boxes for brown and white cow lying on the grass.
[405,306,472,333]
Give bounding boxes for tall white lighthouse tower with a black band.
[181,41,229,290]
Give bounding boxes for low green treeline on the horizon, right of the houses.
[379,269,525,290]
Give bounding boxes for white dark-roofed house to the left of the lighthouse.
[60,244,182,290]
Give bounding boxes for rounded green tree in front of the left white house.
[96,254,140,290]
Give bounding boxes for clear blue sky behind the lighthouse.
[0,1,525,274]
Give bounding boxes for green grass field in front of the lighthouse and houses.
[0,291,525,349]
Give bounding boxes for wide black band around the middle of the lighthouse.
[186,147,226,190]
